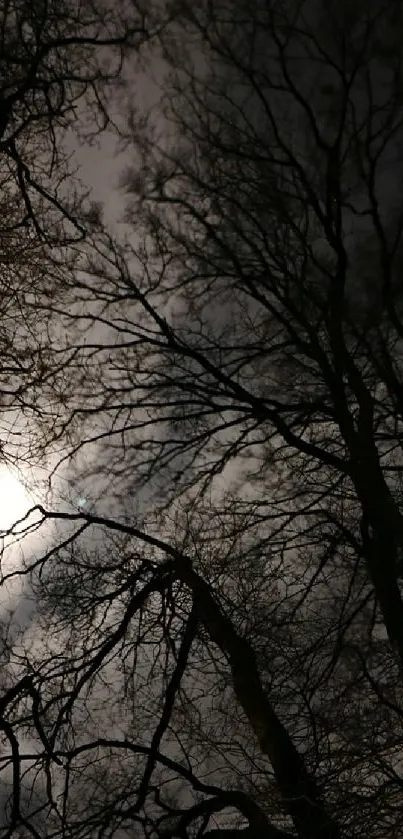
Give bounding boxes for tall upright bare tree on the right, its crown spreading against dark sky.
[110,3,403,658]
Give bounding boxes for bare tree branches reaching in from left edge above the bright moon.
[0,0,172,460]
